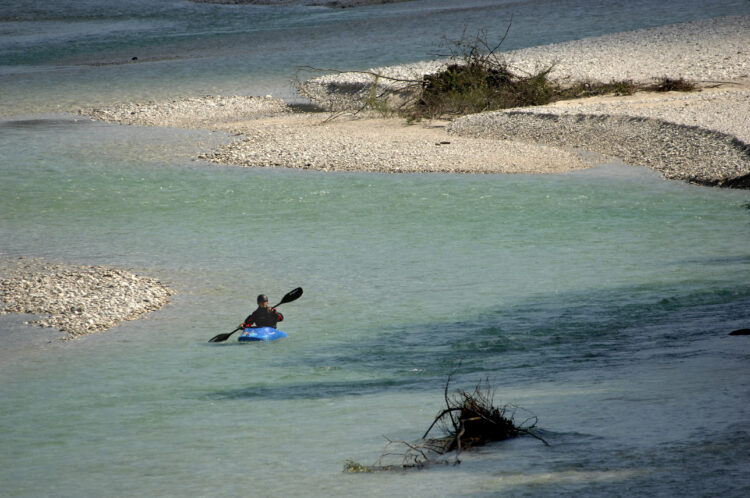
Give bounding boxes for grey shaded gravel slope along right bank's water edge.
[449,111,750,188]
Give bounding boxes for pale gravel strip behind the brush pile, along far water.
[298,16,750,110]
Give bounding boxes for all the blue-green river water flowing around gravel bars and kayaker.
[0,0,750,497]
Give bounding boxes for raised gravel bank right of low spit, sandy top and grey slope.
[448,86,750,188]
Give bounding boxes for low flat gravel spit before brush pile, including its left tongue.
[79,96,591,173]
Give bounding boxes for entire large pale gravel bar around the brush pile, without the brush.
[81,16,750,187]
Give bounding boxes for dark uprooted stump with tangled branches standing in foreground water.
[344,378,549,472]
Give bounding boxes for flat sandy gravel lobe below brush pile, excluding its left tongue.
[201,114,590,173]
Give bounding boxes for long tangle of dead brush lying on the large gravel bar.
[297,24,697,121]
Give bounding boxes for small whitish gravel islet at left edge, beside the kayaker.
[0,258,174,339]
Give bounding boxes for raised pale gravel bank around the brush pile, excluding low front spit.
[290,16,750,188]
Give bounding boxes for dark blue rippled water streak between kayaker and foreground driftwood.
[194,282,750,401]
